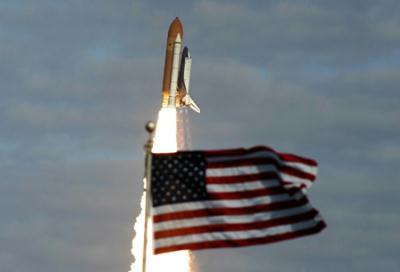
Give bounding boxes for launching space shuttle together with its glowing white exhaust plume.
[130,18,200,272]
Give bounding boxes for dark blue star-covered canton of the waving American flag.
[151,152,208,207]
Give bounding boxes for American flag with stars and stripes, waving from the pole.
[151,146,326,254]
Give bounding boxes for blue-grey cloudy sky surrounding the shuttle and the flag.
[0,0,400,272]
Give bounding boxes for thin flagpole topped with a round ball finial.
[142,121,156,272]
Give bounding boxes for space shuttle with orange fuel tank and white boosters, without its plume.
[162,17,200,112]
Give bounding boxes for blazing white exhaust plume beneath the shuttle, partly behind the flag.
[130,108,193,272]
